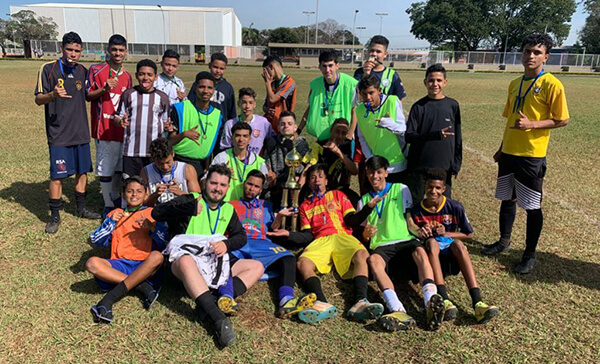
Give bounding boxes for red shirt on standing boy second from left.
[87,62,133,142]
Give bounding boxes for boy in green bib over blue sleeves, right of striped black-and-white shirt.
[169,72,223,176]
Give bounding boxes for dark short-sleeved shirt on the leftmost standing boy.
[35,61,90,147]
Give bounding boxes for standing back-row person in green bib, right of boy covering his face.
[298,51,358,141]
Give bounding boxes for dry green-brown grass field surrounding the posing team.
[0,61,600,363]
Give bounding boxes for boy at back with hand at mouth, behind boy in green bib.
[354,35,406,100]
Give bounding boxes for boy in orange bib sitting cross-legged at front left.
[85,176,168,323]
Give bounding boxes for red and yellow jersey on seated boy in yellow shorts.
[299,190,355,239]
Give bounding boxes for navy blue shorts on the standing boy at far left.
[49,143,92,179]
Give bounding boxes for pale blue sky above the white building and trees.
[0,0,586,48]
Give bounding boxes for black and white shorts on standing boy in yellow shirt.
[496,153,546,210]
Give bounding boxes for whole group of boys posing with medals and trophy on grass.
[36,32,568,346]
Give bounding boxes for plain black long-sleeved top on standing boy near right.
[406,96,462,174]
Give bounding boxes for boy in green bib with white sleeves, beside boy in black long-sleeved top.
[353,76,407,183]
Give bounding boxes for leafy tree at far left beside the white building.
[6,10,58,58]
